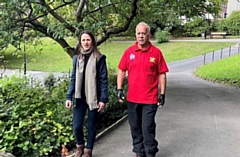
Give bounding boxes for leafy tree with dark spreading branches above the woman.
[0,0,138,57]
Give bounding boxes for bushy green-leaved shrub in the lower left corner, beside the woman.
[0,76,73,157]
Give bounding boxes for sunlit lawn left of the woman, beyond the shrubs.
[4,38,76,72]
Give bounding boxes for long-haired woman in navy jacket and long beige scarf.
[66,31,108,157]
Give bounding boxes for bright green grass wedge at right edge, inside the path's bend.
[195,54,240,87]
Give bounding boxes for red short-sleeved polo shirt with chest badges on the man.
[118,42,168,104]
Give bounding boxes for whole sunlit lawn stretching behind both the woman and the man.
[0,38,238,72]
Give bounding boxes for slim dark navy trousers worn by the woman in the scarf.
[73,99,98,149]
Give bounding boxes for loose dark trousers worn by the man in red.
[128,102,158,157]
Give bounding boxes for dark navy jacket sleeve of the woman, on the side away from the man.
[67,55,77,100]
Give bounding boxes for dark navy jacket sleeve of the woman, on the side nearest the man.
[98,55,108,103]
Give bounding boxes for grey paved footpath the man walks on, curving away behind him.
[1,40,240,157]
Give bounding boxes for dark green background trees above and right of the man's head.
[123,0,227,34]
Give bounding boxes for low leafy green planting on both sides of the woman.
[0,71,126,157]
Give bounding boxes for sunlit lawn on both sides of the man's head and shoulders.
[100,42,236,69]
